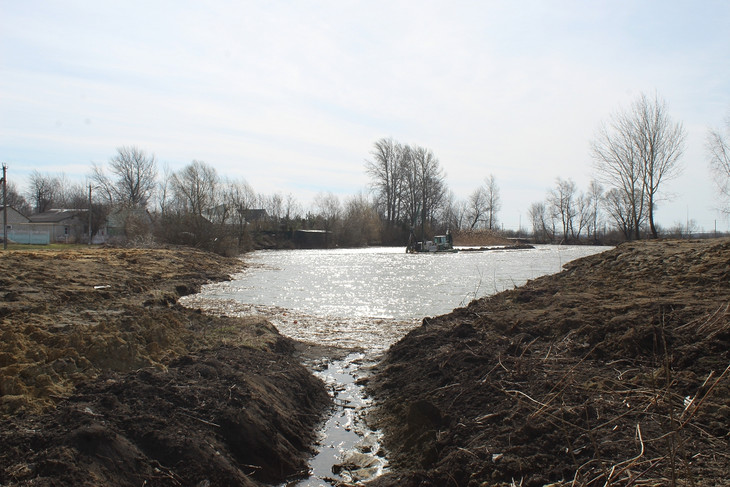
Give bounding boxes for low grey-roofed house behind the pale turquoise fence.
[25,209,89,244]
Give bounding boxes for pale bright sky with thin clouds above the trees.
[0,0,730,231]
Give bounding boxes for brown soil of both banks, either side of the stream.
[0,239,730,487]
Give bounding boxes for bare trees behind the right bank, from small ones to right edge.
[528,94,730,243]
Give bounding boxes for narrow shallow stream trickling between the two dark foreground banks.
[282,352,387,487]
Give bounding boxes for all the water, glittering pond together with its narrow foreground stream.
[183,245,609,487]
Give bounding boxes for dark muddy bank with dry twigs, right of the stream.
[369,239,730,486]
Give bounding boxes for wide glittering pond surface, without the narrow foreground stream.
[182,245,609,351]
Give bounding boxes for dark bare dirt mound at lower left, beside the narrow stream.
[0,346,329,486]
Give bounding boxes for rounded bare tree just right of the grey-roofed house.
[91,146,157,208]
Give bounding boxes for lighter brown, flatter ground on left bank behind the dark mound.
[0,249,240,414]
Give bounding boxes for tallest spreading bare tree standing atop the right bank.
[592,94,686,238]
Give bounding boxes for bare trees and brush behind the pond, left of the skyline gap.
[2,139,499,252]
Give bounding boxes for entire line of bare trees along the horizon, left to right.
[2,90,730,252]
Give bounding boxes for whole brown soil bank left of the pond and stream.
[0,249,330,486]
